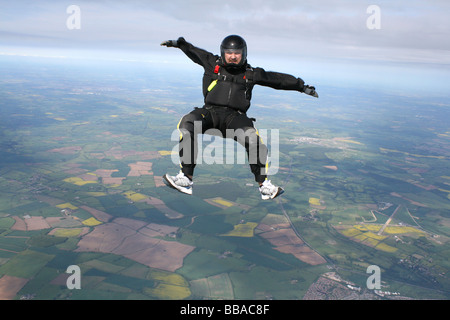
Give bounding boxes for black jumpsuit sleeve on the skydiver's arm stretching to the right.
[254,68,305,92]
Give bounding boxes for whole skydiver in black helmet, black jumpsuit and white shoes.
[161,35,318,200]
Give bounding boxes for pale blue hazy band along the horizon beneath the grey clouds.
[0,48,450,98]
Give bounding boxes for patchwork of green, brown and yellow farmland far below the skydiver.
[0,55,450,300]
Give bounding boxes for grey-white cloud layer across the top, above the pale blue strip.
[0,0,450,64]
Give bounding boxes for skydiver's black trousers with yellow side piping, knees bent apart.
[178,106,268,182]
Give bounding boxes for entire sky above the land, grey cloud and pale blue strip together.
[0,0,450,92]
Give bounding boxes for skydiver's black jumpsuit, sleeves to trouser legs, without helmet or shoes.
[178,38,304,182]
